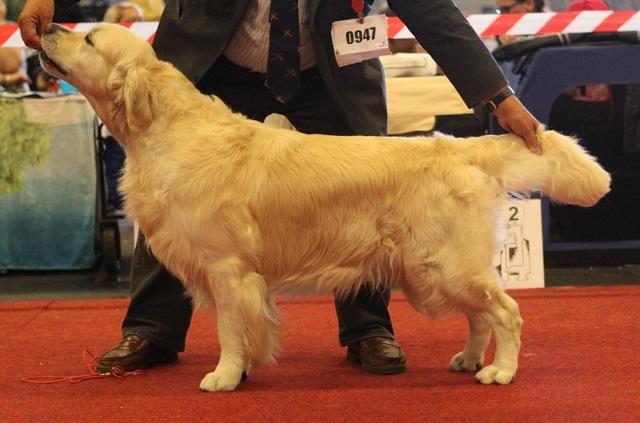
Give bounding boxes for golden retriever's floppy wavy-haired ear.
[107,61,154,131]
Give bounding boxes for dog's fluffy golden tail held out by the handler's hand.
[470,130,611,207]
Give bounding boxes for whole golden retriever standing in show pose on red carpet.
[41,24,610,391]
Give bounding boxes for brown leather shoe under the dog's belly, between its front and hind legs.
[347,336,407,375]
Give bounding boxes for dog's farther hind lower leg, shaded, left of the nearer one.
[449,312,491,372]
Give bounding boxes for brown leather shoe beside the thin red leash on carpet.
[96,334,178,373]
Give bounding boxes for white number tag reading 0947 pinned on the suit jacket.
[331,15,390,66]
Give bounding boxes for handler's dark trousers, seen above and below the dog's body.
[122,58,393,351]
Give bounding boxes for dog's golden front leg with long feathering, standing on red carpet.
[200,263,278,391]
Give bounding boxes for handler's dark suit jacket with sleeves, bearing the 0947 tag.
[57,0,506,135]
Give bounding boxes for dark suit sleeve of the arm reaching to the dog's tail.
[388,0,507,107]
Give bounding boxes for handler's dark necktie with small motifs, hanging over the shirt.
[265,0,300,104]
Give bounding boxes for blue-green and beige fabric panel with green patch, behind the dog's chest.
[0,95,97,270]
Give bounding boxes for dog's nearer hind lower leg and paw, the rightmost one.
[475,287,522,385]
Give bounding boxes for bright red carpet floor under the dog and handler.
[0,286,640,422]
